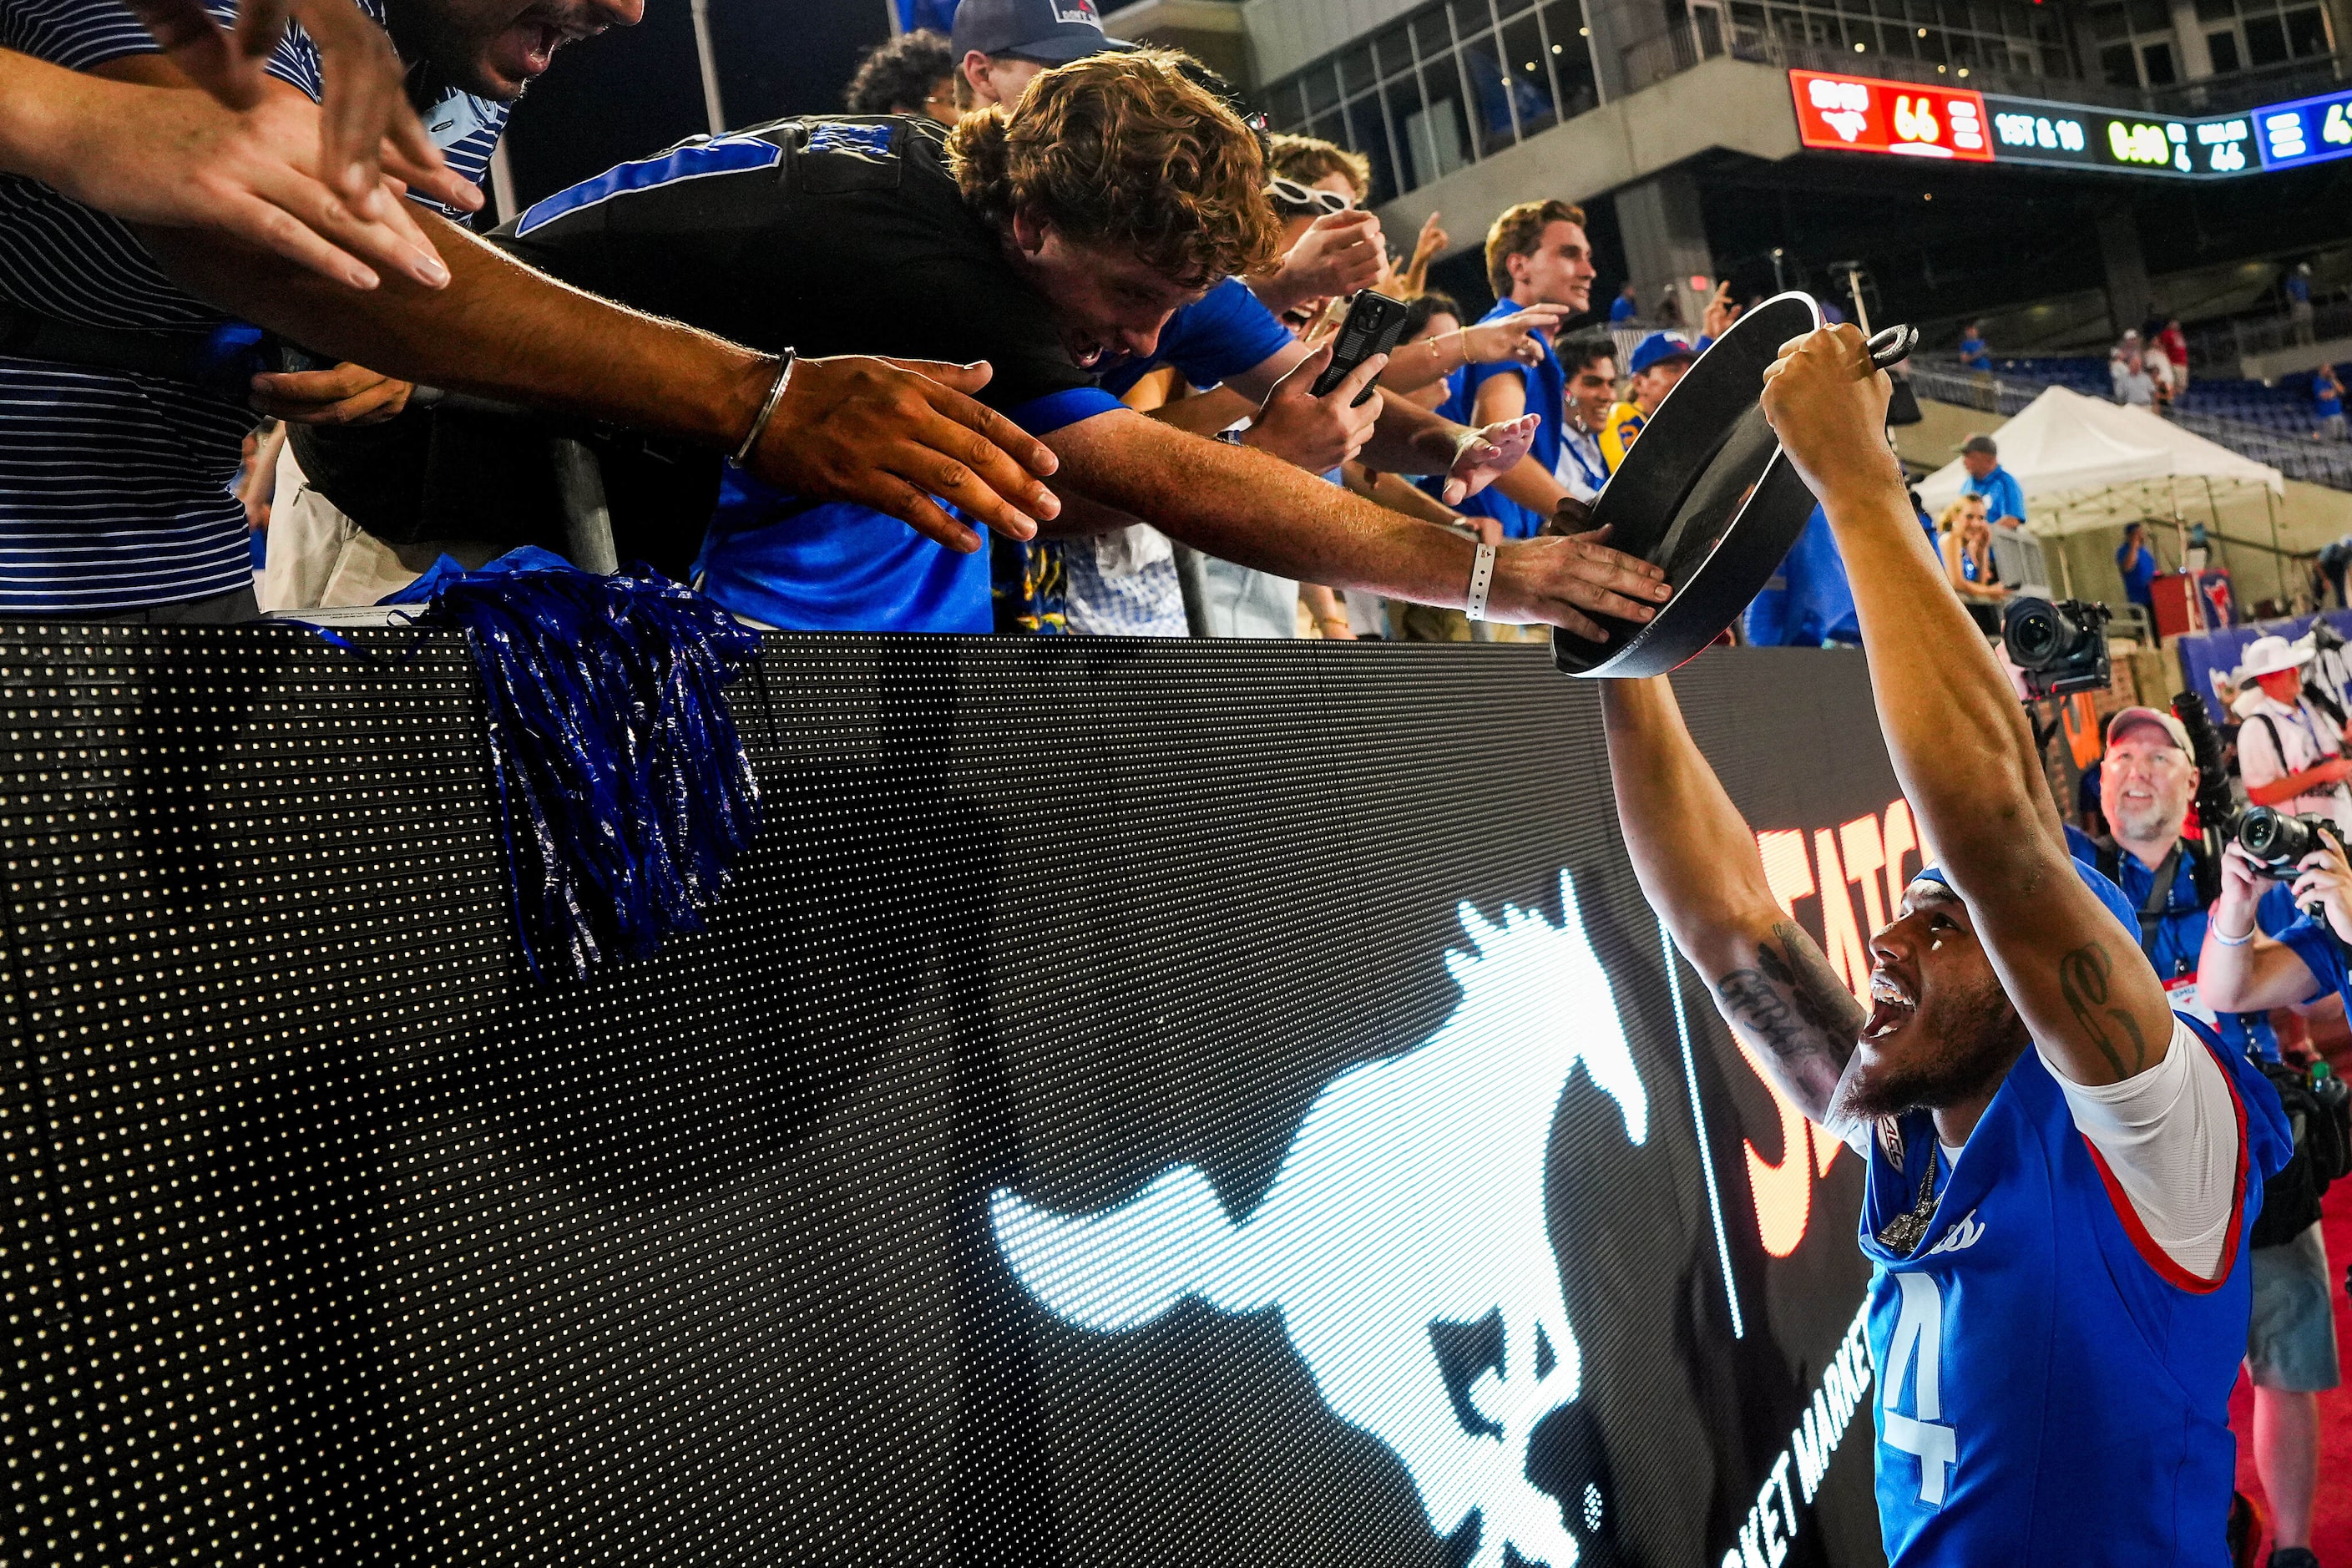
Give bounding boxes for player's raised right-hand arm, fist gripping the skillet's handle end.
[1764,326,2173,1084]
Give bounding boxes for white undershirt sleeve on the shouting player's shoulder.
[2035,1018,2237,1279]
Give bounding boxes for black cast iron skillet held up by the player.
[1552,291,1920,677]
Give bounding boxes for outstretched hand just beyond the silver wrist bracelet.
[751,355,1060,554]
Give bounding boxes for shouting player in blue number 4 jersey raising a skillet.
[1604,326,2289,1568]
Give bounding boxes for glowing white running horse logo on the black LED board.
[993,873,1649,1568]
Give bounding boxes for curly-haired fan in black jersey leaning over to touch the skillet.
[482,52,1667,637]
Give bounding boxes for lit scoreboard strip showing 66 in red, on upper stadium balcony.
[1788,70,2352,179]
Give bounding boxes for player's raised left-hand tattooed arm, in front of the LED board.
[1601,675,1865,1126]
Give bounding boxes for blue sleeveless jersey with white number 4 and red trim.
[1860,1020,2289,1568]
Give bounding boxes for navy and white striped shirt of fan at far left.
[0,0,506,616]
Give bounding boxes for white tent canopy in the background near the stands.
[1920,386,2286,534]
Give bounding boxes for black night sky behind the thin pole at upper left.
[508,0,889,215]
